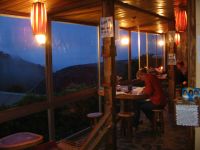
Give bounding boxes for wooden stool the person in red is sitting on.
[153,109,164,135]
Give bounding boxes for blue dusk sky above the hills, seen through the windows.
[0,17,161,71]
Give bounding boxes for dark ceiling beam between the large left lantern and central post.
[49,0,99,16]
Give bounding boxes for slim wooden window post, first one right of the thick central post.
[128,30,132,83]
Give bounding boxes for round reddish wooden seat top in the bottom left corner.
[0,132,43,150]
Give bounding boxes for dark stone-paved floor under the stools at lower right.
[57,102,192,150]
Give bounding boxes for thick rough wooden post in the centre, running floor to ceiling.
[102,0,117,150]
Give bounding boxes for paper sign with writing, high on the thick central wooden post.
[100,17,114,38]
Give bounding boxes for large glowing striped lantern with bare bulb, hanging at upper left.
[31,2,47,44]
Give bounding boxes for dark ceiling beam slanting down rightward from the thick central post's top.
[115,0,172,21]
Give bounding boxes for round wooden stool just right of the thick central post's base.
[118,112,134,137]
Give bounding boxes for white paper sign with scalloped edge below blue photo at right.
[176,104,199,126]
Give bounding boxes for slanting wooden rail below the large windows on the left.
[0,88,97,123]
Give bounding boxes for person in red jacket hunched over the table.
[133,68,167,128]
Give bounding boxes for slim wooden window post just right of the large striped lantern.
[45,17,55,140]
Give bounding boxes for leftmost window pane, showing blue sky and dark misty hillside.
[0,17,46,109]
